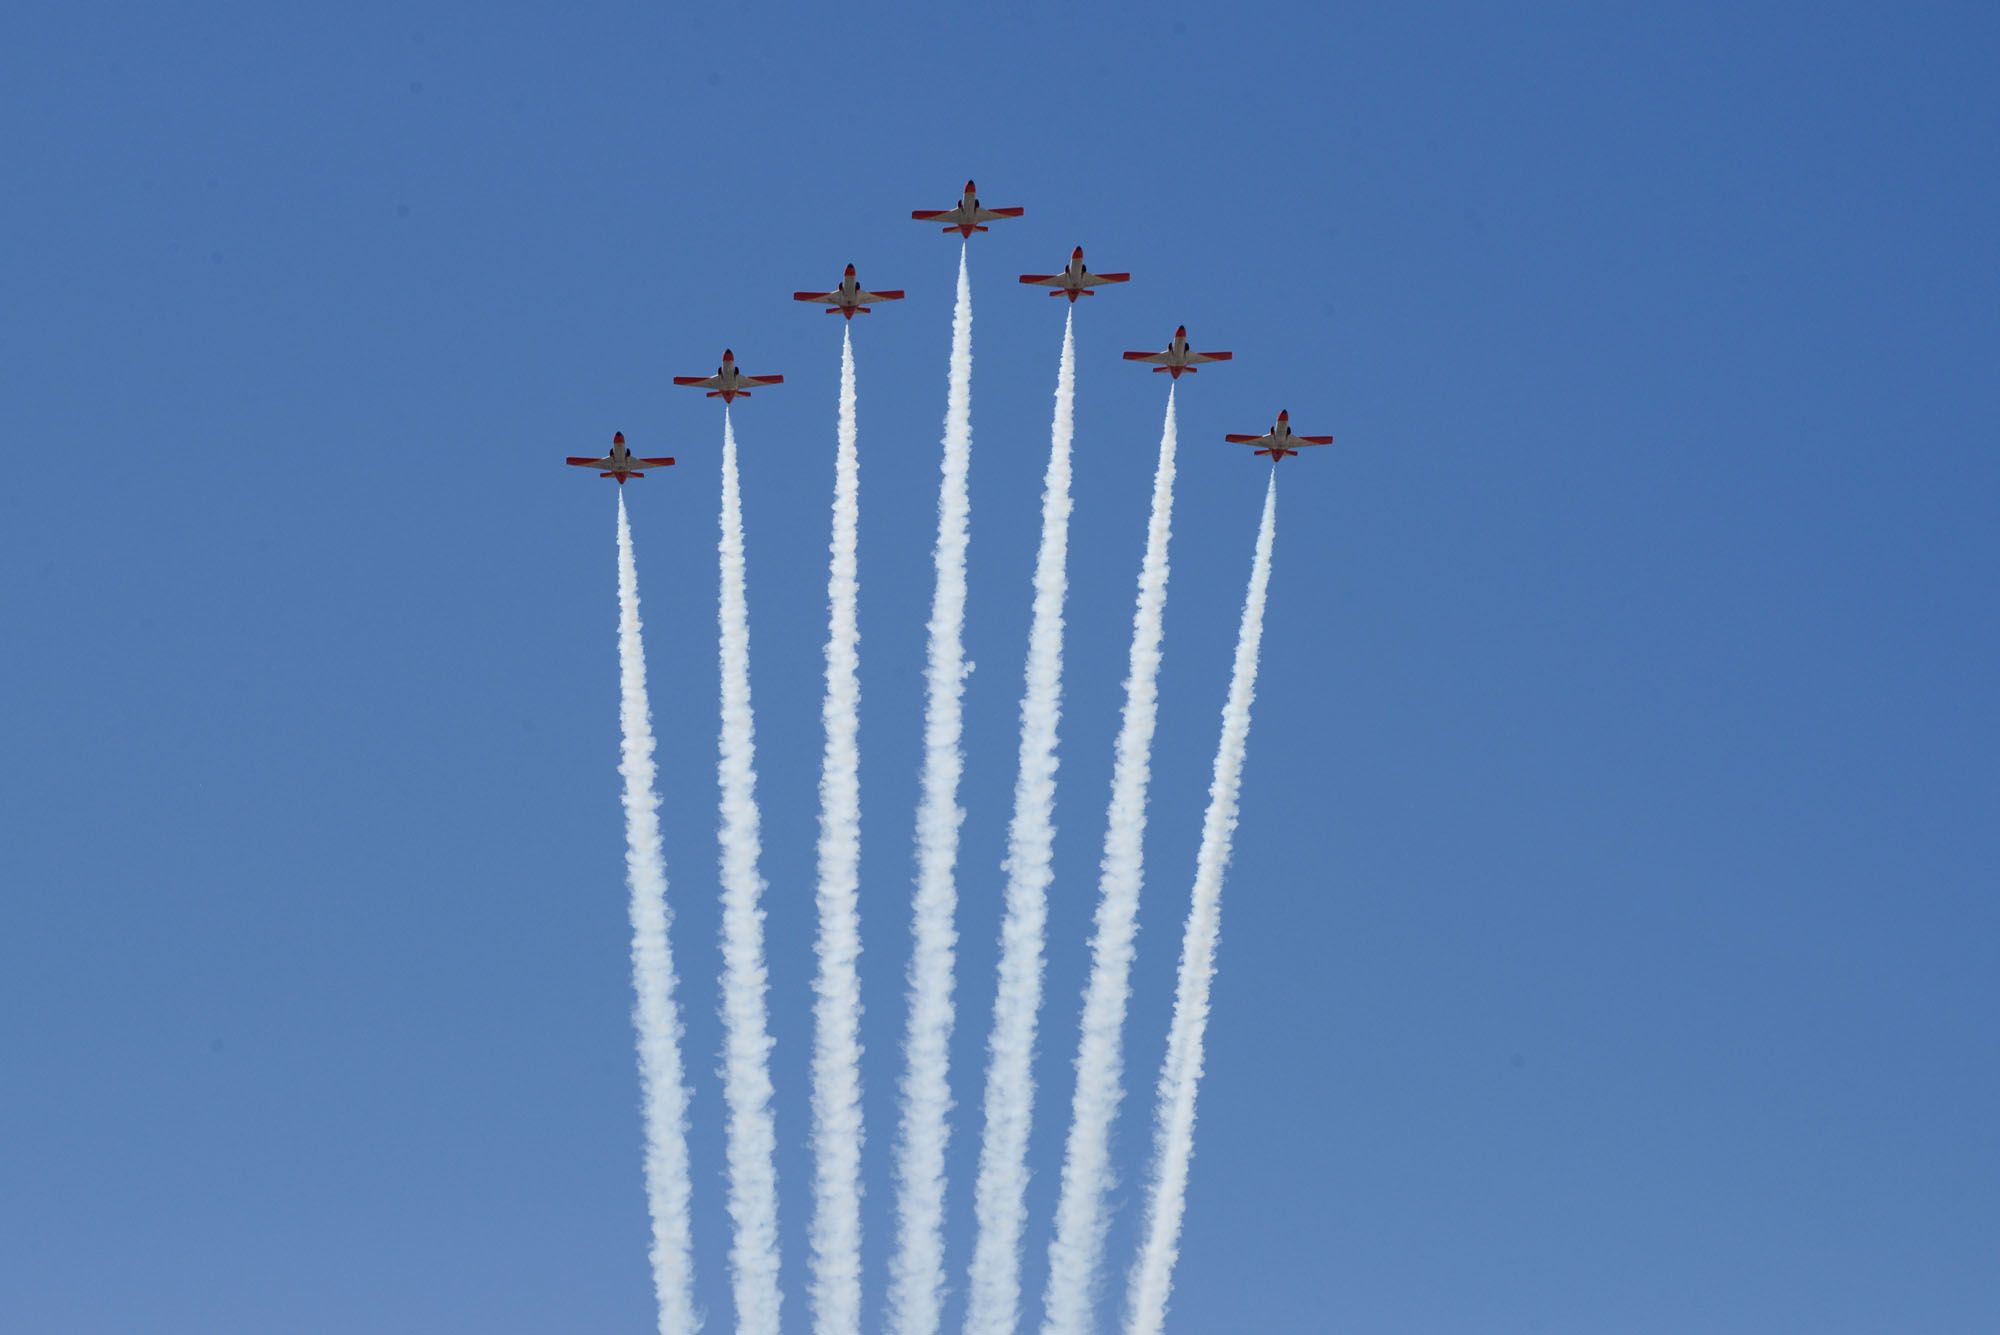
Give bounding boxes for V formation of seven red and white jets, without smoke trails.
[564,180,1334,486]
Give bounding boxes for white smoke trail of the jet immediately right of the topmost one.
[966,309,1076,1335]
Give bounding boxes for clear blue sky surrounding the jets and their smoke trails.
[0,4,2000,1335]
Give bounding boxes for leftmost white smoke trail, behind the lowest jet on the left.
[618,492,702,1335]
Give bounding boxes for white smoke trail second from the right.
[1042,390,1176,1335]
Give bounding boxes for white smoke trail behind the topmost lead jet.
[890,248,972,1335]
